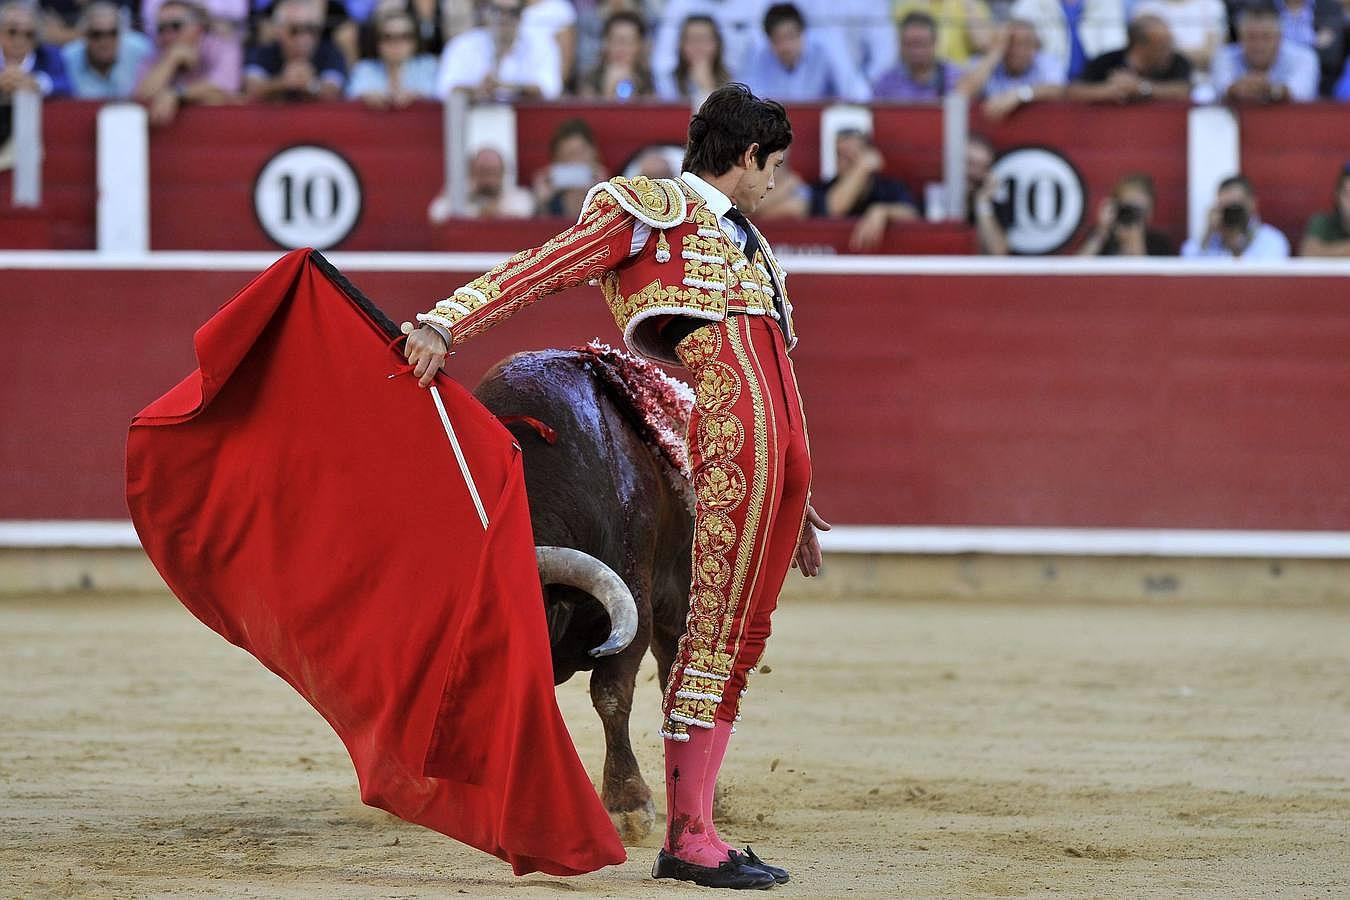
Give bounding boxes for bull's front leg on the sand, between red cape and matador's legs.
[590,612,656,845]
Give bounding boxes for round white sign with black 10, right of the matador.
[994,147,1084,255]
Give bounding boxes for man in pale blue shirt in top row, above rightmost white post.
[1214,5,1319,103]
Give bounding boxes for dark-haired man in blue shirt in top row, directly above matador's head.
[741,3,872,103]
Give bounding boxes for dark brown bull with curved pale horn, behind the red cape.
[474,344,694,843]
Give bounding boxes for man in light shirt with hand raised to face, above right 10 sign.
[960,19,1064,120]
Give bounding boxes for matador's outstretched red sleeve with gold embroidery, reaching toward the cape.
[417,190,636,344]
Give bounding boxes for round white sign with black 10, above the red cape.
[254,144,360,250]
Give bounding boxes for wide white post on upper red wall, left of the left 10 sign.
[97,103,150,256]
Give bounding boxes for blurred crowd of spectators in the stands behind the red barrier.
[0,0,1350,258]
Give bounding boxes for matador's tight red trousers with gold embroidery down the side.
[662,316,811,741]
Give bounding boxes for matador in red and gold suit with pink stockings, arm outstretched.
[405,85,829,888]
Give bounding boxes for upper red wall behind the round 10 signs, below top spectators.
[10,101,1350,252]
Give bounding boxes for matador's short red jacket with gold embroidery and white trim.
[417,177,797,366]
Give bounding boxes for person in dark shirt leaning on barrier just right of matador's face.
[811,129,922,250]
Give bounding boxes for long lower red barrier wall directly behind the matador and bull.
[0,260,1350,530]
